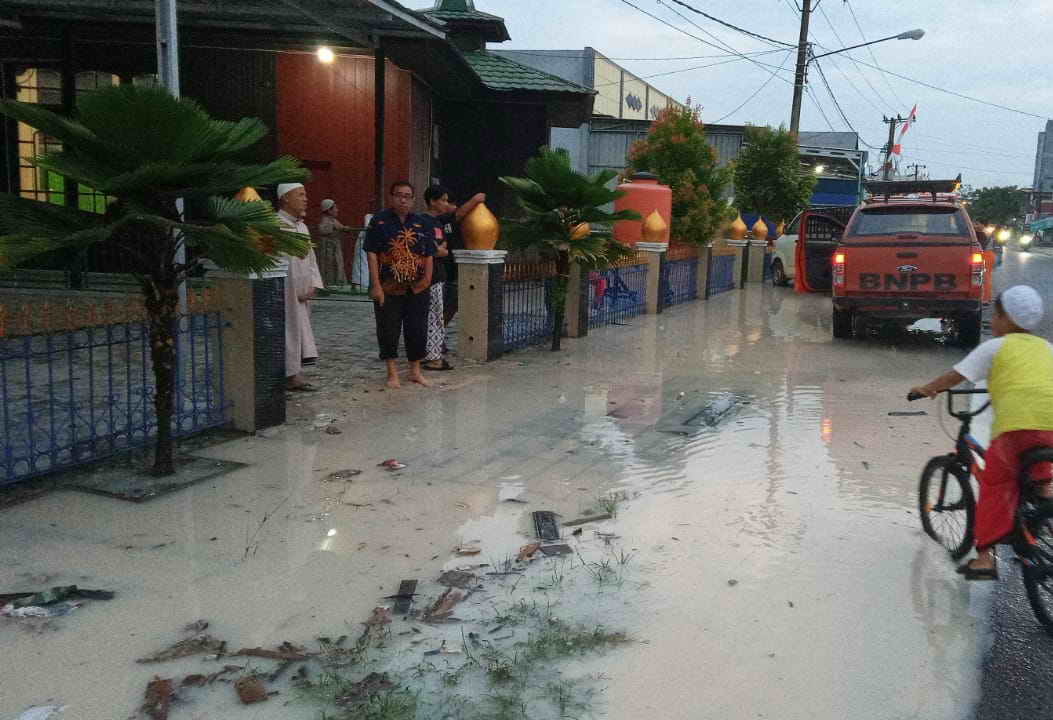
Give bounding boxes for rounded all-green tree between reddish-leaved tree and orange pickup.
[735,127,818,222]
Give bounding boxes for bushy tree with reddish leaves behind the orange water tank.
[623,98,731,244]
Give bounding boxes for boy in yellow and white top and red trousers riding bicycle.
[911,285,1053,580]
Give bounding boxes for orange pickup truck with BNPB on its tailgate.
[832,180,991,346]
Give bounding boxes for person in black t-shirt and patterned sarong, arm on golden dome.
[423,185,486,371]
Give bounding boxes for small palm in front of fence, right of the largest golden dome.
[500,147,640,351]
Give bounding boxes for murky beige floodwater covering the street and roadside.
[0,286,990,720]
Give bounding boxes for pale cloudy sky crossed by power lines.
[465,0,1053,187]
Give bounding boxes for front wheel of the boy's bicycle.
[918,455,976,560]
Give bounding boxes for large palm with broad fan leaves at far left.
[0,85,307,475]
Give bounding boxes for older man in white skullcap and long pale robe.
[278,182,324,392]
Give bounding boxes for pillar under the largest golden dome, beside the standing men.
[454,249,508,362]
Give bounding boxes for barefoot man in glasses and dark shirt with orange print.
[365,181,436,389]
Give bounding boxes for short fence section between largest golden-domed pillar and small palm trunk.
[501,262,556,349]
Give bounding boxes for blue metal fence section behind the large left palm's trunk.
[0,298,227,485]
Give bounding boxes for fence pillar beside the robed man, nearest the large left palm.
[208,271,285,433]
